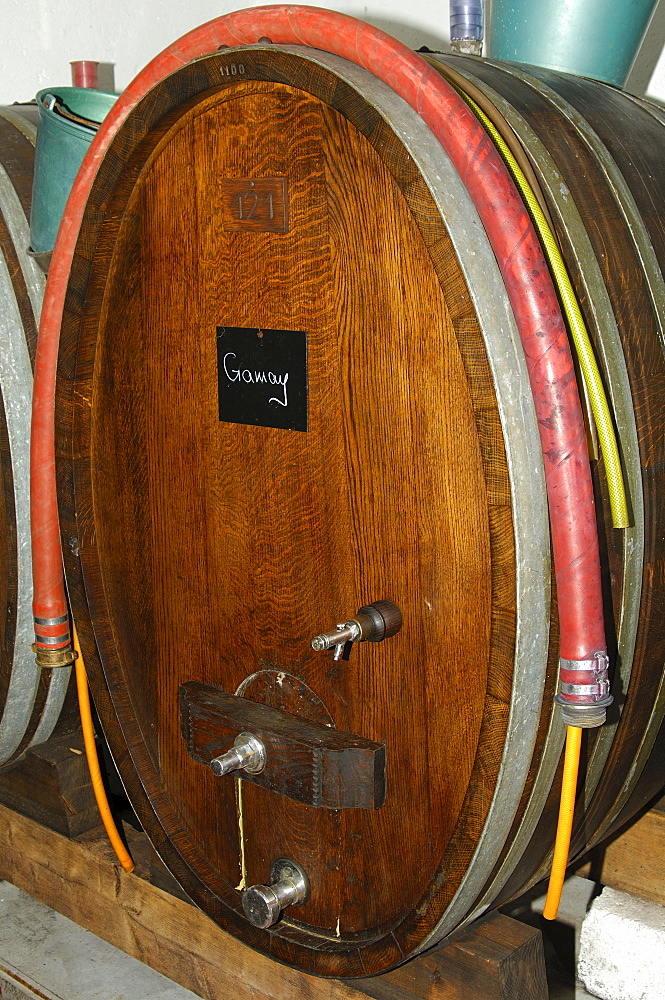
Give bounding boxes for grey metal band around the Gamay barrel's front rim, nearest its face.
[300,46,550,951]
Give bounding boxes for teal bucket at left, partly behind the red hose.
[30,87,118,253]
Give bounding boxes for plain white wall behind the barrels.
[0,0,665,104]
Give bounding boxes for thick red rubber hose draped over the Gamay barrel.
[32,5,605,704]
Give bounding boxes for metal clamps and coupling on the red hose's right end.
[554,649,614,729]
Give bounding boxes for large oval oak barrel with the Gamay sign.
[56,43,665,977]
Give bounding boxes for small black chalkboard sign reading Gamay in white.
[217,326,307,431]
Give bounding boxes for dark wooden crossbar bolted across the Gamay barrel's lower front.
[180,681,386,809]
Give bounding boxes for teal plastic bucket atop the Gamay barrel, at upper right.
[487,0,657,87]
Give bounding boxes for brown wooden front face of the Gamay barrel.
[58,51,516,976]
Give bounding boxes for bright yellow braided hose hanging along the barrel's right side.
[457,94,629,528]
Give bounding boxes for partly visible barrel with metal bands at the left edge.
[0,105,69,767]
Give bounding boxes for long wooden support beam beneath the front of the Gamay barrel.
[0,805,548,1000]
